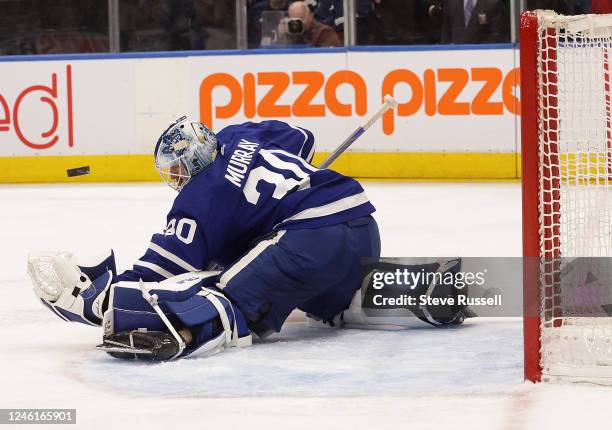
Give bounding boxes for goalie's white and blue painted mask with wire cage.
[155,116,217,191]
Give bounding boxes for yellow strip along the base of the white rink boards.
[0,152,520,183]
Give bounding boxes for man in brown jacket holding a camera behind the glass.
[281,1,342,47]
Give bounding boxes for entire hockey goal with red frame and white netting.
[520,11,612,384]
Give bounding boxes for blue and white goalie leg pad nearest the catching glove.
[100,273,251,360]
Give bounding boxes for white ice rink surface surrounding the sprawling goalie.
[0,182,612,430]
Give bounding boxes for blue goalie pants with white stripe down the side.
[219,216,380,335]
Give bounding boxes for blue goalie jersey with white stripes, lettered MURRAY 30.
[114,121,375,282]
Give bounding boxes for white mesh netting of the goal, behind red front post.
[537,11,612,382]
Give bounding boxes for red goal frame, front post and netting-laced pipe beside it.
[520,12,561,382]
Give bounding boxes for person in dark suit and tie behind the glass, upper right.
[441,0,510,43]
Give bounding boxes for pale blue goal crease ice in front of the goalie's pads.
[79,322,522,397]
